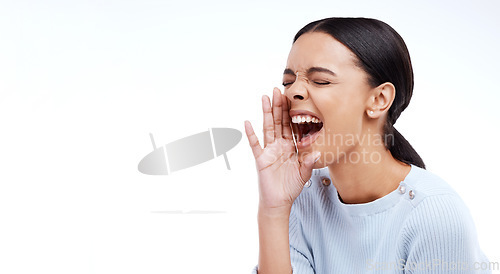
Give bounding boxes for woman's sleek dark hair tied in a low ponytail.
[293,17,425,169]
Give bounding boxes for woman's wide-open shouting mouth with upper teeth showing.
[291,115,323,145]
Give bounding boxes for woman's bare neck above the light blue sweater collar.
[328,145,411,204]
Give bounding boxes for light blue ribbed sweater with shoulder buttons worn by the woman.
[252,165,493,274]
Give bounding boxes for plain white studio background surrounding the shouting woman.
[0,0,500,274]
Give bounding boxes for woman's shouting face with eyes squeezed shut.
[283,32,373,168]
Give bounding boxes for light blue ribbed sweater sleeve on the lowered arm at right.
[403,194,491,273]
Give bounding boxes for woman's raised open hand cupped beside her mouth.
[245,88,320,209]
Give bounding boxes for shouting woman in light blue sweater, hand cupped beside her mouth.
[245,18,490,274]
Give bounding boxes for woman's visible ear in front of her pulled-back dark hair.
[366,82,396,118]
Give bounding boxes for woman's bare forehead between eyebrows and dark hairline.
[287,32,356,72]
